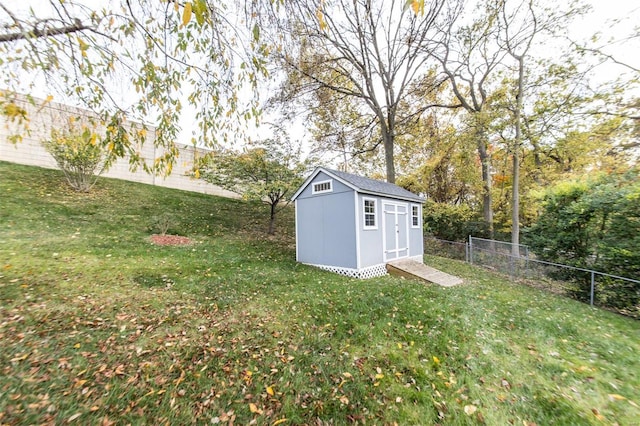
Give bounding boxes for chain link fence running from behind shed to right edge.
[424,236,640,318]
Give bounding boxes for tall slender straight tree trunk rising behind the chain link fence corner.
[511,55,524,257]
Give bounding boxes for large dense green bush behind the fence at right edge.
[524,168,640,308]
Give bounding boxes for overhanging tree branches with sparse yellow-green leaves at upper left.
[0,0,267,171]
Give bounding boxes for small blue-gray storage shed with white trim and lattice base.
[292,167,424,278]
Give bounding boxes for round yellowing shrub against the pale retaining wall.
[42,120,112,192]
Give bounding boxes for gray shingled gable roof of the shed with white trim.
[292,167,424,203]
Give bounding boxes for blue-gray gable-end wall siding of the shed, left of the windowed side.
[296,173,358,269]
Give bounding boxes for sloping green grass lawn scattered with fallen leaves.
[0,162,640,426]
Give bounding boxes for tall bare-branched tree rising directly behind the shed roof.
[262,0,458,182]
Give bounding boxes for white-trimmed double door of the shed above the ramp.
[382,202,409,262]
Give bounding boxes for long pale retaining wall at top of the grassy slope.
[0,94,238,198]
